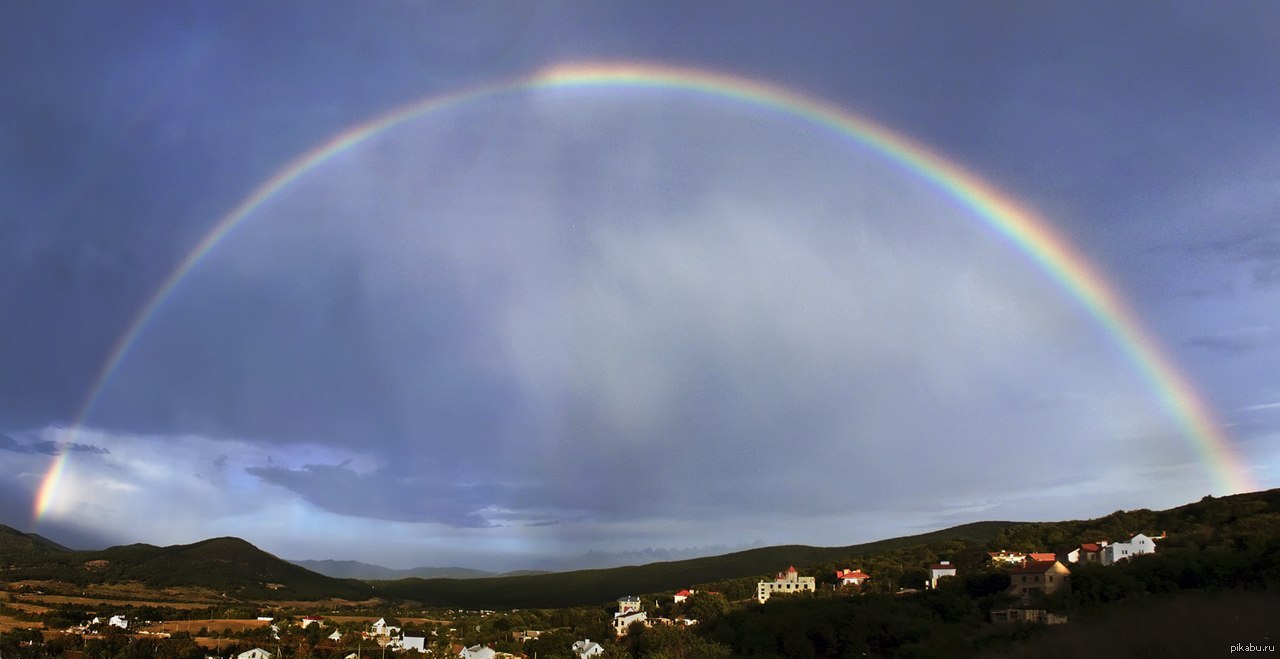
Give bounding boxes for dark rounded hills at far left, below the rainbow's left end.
[0,526,374,600]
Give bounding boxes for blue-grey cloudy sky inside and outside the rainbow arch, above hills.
[0,3,1280,569]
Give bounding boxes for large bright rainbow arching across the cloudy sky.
[35,63,1256,521]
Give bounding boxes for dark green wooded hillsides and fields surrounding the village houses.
[0,490,1280,659]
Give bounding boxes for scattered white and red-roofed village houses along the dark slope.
[12,534,1166,659]
